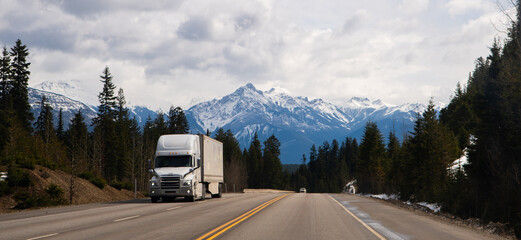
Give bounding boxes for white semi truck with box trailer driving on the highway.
[149,134,224,203]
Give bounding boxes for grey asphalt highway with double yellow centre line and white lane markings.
[0,193,499,240]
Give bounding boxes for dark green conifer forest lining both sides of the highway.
[0,2,521,237]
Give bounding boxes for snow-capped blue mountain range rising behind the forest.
[29,82,425,164]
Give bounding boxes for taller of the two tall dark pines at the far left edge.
[8,39,34,133]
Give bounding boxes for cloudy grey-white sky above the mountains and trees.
[0,0,511,110]
